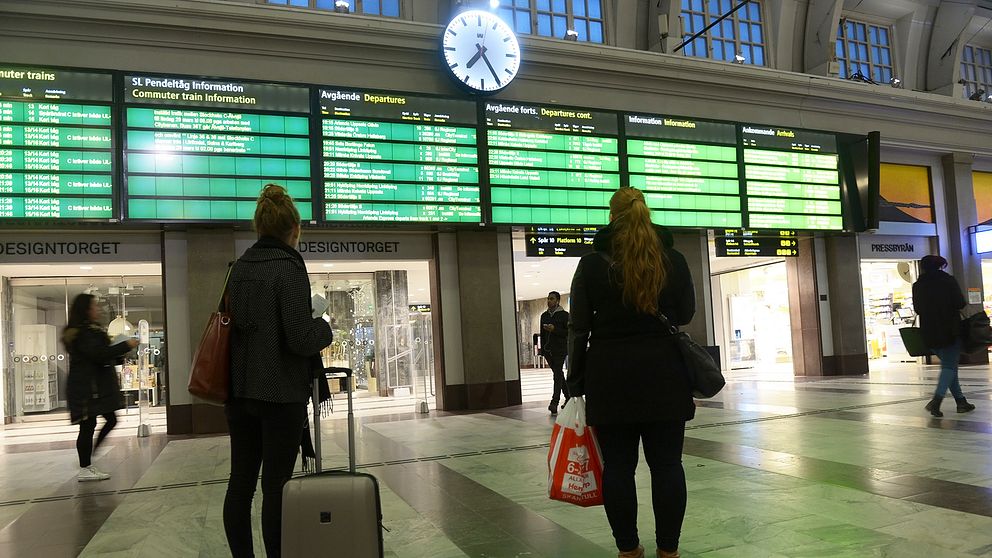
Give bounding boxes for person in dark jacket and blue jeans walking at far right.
[913,254,975,417]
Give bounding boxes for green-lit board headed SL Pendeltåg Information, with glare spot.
[124,75,314,222]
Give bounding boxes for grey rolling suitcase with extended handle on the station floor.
[282,368,383,558]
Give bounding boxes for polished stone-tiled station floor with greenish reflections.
[0,365,992,558]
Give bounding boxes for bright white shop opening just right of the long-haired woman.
[712,258,793,376]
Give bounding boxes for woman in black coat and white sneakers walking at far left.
[62,293,138,481]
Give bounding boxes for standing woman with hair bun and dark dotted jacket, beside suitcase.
[224,184,331,558]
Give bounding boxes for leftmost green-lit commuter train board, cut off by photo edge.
[0,66,117,221]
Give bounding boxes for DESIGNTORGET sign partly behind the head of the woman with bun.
[235,231,434,261]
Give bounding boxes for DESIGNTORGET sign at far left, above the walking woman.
[0,232,162,264]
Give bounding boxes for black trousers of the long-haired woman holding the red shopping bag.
[596,421,686,552]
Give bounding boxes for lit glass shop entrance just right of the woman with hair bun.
[307,261,437,412]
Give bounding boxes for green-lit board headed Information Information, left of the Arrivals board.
[624,114,743,227]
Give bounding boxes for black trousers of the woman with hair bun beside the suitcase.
[224,399,307,558]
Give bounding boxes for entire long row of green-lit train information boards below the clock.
[0,64,856,230]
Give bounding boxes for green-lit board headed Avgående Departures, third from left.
[320,89,482,223]
